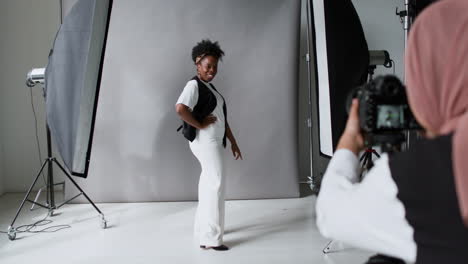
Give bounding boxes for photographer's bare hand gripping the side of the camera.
[336,99,364,155]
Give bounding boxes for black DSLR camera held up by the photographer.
[347,75,421,151]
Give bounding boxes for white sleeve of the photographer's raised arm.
[316,149,416,262]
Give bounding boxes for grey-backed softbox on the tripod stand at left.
[45,0,112,177]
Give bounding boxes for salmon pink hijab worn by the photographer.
[405,0,468,226]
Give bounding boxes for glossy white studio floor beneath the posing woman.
[0,193,373,264]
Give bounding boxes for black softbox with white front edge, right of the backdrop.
[310,0,369,188]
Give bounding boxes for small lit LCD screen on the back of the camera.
[377,105,405,130]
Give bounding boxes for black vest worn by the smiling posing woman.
[177,76,227,147]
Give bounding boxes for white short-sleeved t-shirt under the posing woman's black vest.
[176,80,226,144]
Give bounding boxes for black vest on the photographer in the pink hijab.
[390,135,468,264]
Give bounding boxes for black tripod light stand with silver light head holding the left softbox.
[7,69,107,240]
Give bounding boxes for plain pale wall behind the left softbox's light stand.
[0,0,60,193]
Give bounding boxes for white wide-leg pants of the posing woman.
[190,143,225,246]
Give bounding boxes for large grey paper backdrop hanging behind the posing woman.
[64,0,300,202]
